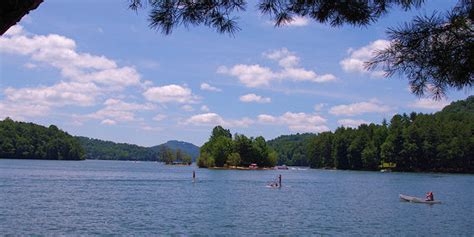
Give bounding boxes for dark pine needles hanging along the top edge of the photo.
[129,0,423,34]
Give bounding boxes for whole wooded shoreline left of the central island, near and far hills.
[0,118,192,164]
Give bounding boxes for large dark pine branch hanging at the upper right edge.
[367,0,474,98]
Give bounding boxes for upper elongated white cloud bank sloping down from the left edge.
[0,26,140,90]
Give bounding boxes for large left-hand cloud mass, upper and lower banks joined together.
[0,25,141,120]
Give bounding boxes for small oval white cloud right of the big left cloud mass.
[143,84,199,104]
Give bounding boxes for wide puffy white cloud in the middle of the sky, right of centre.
[217,48,336,87]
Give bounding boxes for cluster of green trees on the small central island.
[197,126,277,167]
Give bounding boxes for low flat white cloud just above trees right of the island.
[257,112,329,132]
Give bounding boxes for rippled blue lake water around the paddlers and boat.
[0,160,474,236]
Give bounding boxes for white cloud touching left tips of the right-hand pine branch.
[339,40,390,78]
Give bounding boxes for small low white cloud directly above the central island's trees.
[184,113,254,127]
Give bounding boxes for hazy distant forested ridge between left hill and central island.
[76,136,199,161]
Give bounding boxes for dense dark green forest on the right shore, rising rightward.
[269,96,474,173]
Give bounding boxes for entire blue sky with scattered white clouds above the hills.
[0,0,472,146]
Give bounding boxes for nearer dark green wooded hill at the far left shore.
[0,118,85,160]
